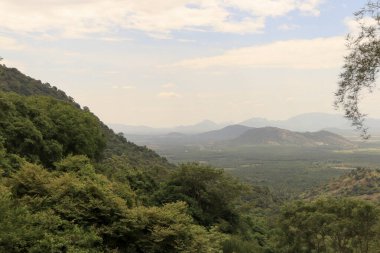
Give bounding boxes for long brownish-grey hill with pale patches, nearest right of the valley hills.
[230,127,355,148]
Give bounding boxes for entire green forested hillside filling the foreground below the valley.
[0,62,380,253]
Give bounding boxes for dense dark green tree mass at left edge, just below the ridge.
[0,93,105,166]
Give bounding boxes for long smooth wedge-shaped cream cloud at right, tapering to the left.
[170,37,346,69]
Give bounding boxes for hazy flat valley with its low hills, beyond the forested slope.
[121,125,380,198]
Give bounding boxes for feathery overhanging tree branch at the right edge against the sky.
[335,0,380,138]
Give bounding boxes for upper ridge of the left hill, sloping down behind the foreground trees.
[0,65,173,174]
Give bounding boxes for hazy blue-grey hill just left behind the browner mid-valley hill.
[194,125,252,141]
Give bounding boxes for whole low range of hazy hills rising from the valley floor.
[126,125,356,148]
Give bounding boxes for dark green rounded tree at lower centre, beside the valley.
[156,163,244,232]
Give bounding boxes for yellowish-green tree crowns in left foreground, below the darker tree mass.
[9,160,134,223]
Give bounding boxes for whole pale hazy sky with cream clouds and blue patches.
[0,0,380,126]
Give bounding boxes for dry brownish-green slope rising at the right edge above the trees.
[304,168,380,202]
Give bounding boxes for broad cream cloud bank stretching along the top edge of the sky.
[0,0,322,38]
